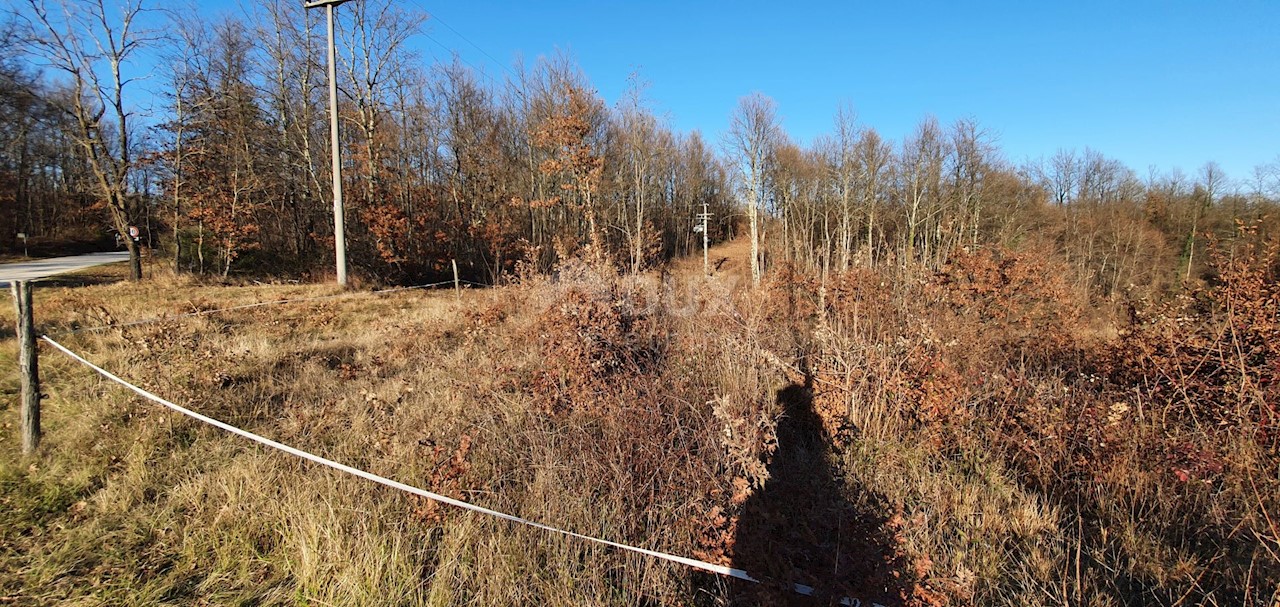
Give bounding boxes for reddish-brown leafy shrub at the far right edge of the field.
[1106,225,1280,455]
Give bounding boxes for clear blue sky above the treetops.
[202,0,1280,183]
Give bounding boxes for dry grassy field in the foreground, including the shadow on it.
[0,243,1280,606]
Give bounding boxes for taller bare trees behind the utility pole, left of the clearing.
[0,0,733,282]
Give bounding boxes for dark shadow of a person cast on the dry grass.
[730,384,906,606]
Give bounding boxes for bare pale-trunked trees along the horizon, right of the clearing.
[726,95,1280,296]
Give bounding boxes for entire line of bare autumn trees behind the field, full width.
[0,0,1280,295]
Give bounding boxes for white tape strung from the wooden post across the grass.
[41,336,884,607]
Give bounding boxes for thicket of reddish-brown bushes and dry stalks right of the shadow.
[737,227,1280,606]
